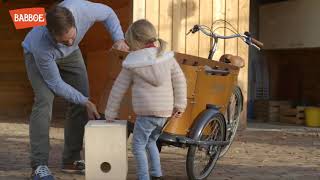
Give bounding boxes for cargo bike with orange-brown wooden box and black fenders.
[98,22,263,179]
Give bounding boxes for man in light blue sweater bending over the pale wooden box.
[22,0,128,180]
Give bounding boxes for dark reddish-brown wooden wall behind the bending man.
[0,0,132,119]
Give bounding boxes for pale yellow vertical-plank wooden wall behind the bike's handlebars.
[133,0,250,127]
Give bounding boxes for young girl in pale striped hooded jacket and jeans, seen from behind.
[105,20,187,180]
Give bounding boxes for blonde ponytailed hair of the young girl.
[125,19,167,55]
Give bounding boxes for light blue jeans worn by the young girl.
[132,116,167,180]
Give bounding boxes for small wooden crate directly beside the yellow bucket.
[280,106,305,125]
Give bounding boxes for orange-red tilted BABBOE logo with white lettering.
[9,7,47,29]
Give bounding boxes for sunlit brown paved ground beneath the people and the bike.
[0,120,320,180]
